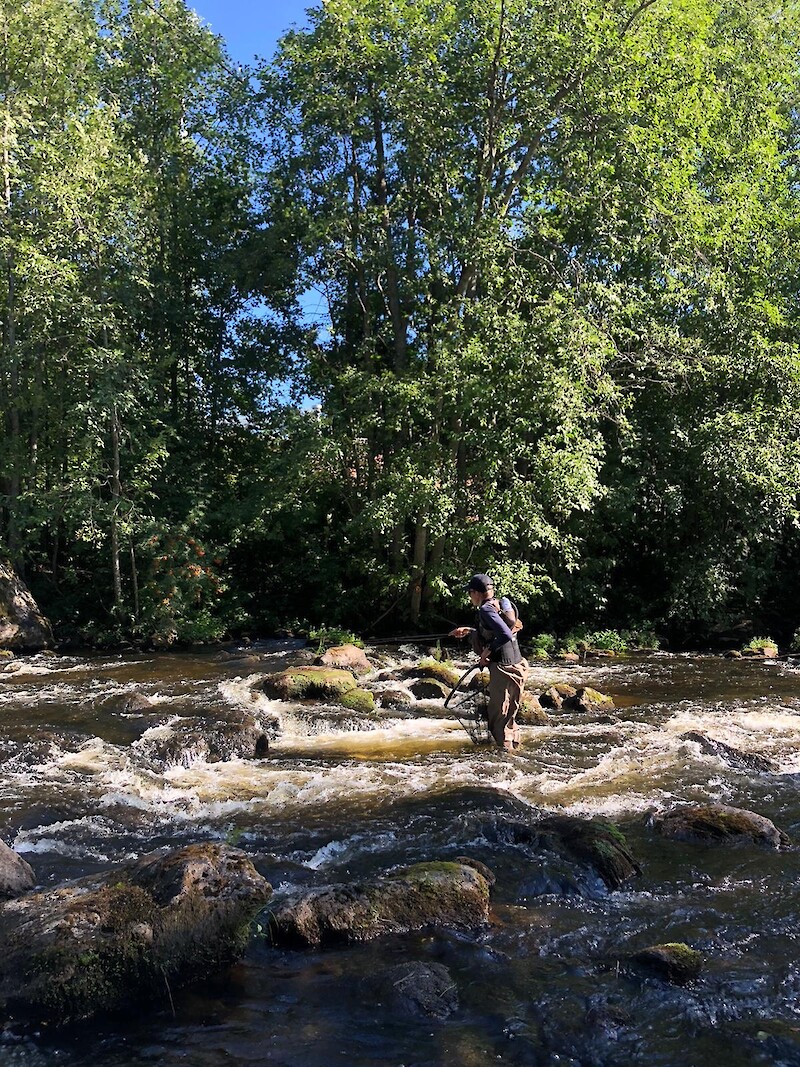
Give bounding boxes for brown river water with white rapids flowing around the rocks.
[0,642,800,1067]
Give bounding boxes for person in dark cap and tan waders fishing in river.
[450,574,528,751]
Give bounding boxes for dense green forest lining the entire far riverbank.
[0,0,800,644]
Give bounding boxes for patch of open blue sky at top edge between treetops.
[187,0,317,63]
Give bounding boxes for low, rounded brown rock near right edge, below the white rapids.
[651,803,790,849]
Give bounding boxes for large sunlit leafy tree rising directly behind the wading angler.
[262,0,794,619]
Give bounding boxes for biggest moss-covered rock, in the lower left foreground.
[0,844,272,1024]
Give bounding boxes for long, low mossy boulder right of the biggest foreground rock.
[269,862,489,947]
